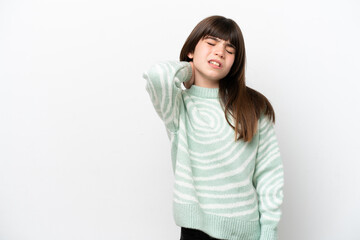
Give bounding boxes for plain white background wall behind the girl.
[0,0,360,240]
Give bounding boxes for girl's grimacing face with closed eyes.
[188,36,235,84]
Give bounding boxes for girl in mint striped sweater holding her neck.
[143,16,284,240]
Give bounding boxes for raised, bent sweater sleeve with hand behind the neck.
[143,61,192,134]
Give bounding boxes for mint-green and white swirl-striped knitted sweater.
[143,61,284,240]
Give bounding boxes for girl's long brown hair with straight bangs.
[180,15,275,142]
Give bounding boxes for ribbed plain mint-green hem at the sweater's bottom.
[173,202,261,240]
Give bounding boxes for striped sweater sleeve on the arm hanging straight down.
[253,114,284,240]
